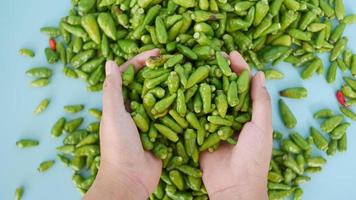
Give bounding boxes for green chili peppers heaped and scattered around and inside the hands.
[18,0,356,200]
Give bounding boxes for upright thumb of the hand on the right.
[251,72,272,130]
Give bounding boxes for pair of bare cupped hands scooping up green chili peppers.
[84,49,272,200]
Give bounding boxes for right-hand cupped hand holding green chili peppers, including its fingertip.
[200,52,272,200]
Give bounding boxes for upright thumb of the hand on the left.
[103,61,126,119]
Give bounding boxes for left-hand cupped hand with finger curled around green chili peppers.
[84,49,162,200]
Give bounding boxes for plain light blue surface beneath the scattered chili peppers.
[0,0,356,200]
